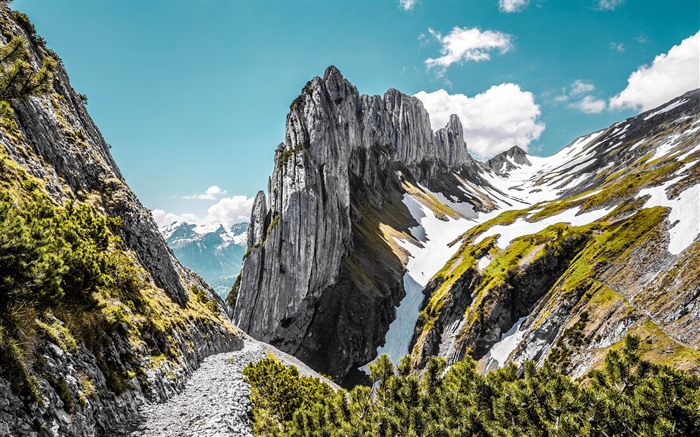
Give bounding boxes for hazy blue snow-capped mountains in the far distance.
[160,222,248,297]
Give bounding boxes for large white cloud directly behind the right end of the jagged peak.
[415,83,544,158]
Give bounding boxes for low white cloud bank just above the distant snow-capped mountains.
[151,196,254,227]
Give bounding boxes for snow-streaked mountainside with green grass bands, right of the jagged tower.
[412,90,700,377]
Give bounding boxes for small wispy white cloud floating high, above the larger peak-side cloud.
[425,27,513,77]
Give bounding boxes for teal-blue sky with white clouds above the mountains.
[11,0,700,226]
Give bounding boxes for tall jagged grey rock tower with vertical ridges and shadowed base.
[233,67,477,379]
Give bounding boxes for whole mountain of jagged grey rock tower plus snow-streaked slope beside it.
[231,67,700,380]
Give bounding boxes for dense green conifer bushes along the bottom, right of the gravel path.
[244,336,700,437]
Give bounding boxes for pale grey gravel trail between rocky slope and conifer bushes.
[130,337,335,437]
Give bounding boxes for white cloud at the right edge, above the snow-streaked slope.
[610,32,700,111]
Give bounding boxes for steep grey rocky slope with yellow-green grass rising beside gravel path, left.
[0,7,242,436]
